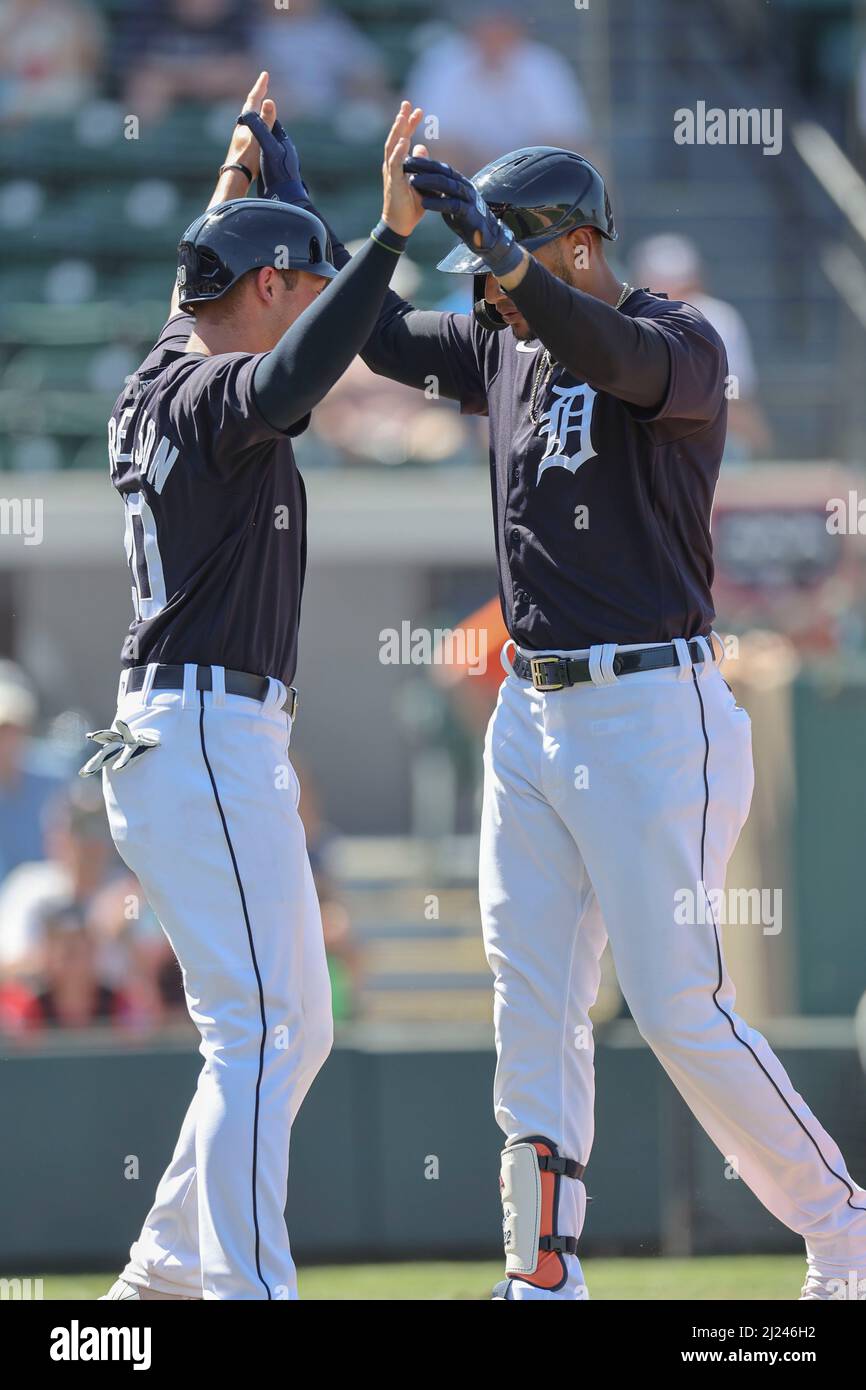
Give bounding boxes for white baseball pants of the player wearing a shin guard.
[480,641,866,1300]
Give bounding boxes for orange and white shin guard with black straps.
[499,1134,584,1291]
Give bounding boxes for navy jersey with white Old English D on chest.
[364,286,727,651]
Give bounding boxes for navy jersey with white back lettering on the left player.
[108,313,309,684]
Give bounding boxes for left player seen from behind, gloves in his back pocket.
[83,74,423,1300]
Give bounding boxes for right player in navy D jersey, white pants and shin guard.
[244,103,866,1301]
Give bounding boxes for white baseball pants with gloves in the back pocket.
[103,666,332,1300]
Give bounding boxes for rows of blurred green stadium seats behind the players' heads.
[0,0,866,466]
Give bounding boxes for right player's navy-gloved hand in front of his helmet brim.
[403,153,523,278]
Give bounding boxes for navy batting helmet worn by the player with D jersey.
[436,145,617,328]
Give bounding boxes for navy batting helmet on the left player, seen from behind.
[178,197,336,311]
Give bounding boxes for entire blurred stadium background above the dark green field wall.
[0,0,866,1056]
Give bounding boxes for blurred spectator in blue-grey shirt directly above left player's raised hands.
[253,0,386,136]
